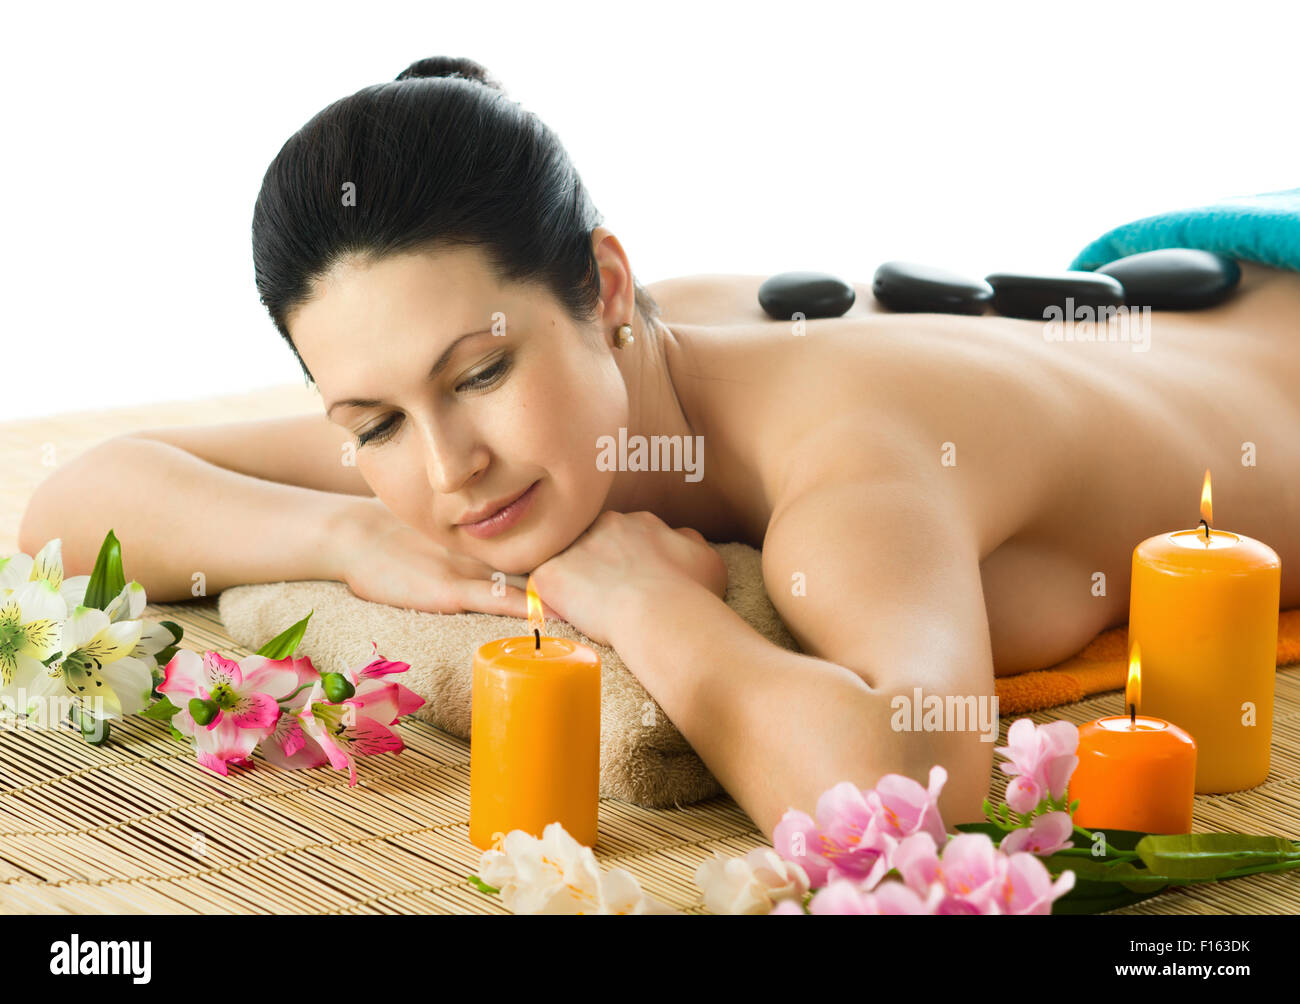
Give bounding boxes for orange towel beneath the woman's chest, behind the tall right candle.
[995,609,1300,715]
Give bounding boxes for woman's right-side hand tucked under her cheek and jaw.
[533,511,727,645]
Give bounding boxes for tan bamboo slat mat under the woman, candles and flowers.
[0,386,1300,914]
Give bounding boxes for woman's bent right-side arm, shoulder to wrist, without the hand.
[611,473,997,839]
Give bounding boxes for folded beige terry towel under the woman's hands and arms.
[218,544,798,809]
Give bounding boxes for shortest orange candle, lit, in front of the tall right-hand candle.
[1066,645,1196,834]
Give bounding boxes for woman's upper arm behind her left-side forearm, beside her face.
[129,412,374,495]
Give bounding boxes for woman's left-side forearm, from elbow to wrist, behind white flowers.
[20,437,356,602]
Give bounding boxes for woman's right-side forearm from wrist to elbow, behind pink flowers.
[611,587,993,839]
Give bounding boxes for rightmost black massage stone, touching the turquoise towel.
[1097,247,1242,311]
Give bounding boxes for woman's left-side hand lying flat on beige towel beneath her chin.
[326,498,528,618]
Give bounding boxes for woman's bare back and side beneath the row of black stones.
[650,265,1300,675]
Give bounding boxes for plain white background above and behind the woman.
[0,0,1300,419]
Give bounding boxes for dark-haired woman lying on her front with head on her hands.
[22,59,1300,838]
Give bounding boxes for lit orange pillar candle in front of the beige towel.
[469,579,601,851]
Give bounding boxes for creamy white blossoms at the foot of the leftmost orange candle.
[478,822,677,914]
